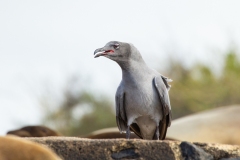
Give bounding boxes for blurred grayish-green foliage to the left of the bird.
[40,77,116,136]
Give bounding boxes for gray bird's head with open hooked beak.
[94,41,131,62]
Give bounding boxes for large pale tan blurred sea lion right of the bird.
[167,105,240,145]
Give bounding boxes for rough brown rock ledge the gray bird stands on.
[26,137,240,160]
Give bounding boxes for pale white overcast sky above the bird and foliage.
[0,0,240,135]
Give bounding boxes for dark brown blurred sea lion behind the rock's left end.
[7,126,61,137]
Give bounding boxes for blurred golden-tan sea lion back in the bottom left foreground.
[0,136,61,160]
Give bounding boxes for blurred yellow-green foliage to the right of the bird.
[168,51,240,119]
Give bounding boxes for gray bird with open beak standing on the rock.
[94,41,172,139]
